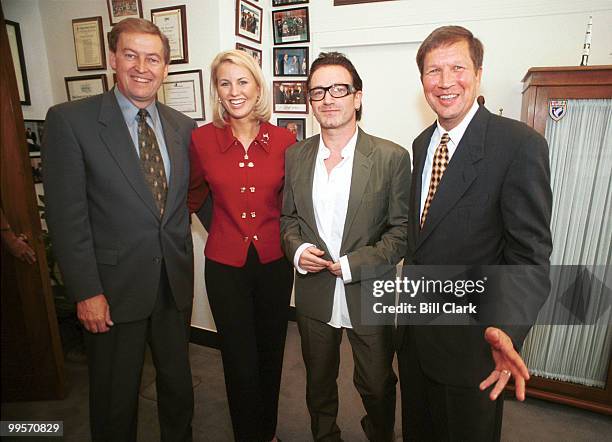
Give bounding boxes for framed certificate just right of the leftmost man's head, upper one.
[151,5,189,64]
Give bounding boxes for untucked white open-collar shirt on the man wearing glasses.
[293,130,357,328]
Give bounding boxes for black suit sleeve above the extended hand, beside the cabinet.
[500,130,552,348]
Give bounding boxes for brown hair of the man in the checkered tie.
[417,26,484,76]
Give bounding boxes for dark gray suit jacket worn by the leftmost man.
[42,91,196,322]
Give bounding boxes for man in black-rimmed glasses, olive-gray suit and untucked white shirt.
[281,52,410,441]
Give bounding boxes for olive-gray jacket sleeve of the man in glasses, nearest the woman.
[280,149,305,262]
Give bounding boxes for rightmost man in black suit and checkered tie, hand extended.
[398,26,552,441]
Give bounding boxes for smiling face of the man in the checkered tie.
[421,40,482,130]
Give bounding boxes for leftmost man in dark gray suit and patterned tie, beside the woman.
[42,19,195,442]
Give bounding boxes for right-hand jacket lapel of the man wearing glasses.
[341,129,372,248]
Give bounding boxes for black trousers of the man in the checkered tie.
[398,337,504,442]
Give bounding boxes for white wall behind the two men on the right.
[310,0,612,147]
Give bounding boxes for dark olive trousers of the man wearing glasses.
[297,312,397,442]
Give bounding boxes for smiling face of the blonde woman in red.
[217,61,260,120]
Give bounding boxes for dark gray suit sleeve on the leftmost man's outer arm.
[42,108,104,302]
